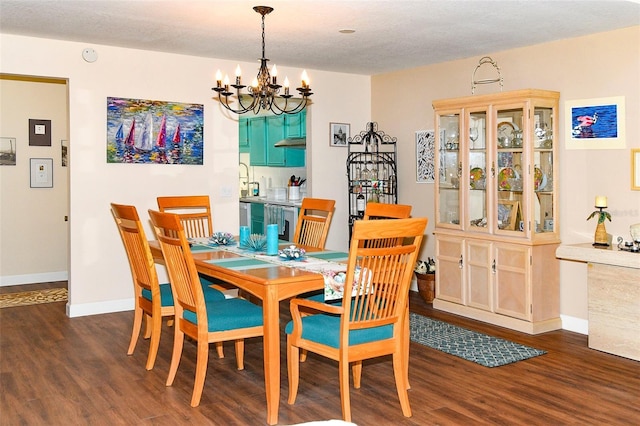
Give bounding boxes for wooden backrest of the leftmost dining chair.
[111,203,159,297]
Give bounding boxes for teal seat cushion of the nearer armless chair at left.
[183,298,262,332]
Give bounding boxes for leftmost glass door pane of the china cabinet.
[437,114,462,227]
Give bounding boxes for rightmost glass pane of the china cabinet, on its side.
[531,107,556,233]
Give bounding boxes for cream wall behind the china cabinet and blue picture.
[372,27,640,332]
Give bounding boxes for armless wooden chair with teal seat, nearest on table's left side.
[149,210,264,407]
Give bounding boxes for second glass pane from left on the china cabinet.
[466,111,488,231]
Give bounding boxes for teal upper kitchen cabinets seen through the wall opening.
[244,114,306,167]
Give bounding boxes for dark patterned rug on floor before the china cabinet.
[410,312,546,367]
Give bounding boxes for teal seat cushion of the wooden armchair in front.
[285,314,393,349]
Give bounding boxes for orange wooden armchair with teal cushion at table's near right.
[285,218,427,421]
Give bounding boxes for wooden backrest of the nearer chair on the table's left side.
[149,210,206,314]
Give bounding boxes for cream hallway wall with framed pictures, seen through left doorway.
[0,78,69,285]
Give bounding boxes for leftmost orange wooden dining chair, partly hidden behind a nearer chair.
[111,203,174,370]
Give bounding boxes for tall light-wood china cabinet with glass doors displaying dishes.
[433,89,561,334]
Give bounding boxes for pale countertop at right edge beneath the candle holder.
[556,243,640,269]
